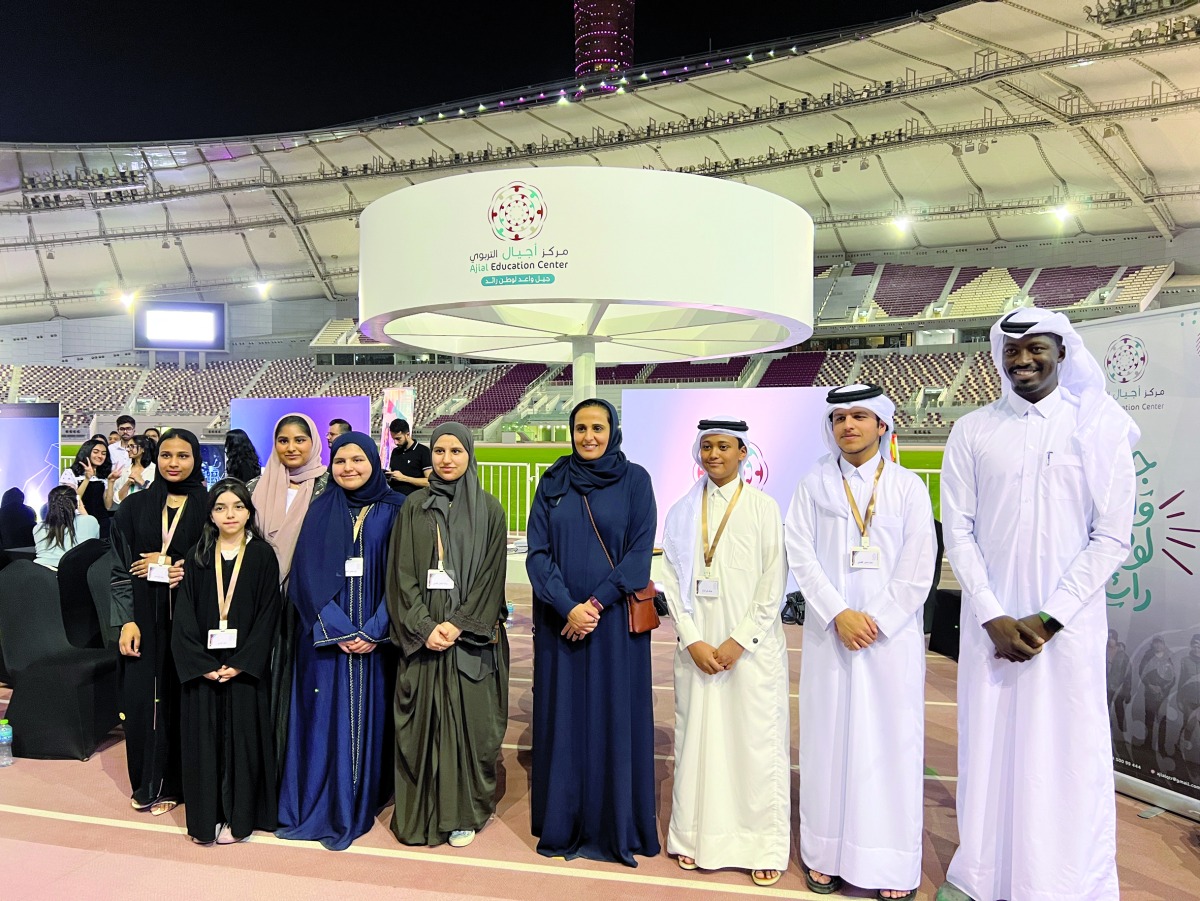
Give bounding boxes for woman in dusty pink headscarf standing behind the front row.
[248,413,329,774]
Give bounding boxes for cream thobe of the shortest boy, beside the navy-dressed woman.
[664,479,792,871]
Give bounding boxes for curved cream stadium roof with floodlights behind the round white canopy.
[0,0,1200,322]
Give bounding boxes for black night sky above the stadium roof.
[0,0,926,143]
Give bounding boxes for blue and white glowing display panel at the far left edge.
[0,403,59,510]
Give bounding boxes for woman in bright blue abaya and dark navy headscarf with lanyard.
[276,432,404,851]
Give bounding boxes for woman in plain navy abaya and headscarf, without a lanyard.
[526,398,659,866]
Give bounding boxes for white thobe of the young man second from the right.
[784,455,936,890]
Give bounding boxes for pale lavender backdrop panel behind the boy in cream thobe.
[620,388,829,542]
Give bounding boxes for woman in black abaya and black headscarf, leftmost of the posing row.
[112,428,208,816]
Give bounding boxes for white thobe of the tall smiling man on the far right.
[942,388,1135,901]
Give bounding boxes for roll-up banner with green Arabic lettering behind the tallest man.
[1078,307,1200,817]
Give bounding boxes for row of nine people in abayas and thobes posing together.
[11,310,1138,901]
